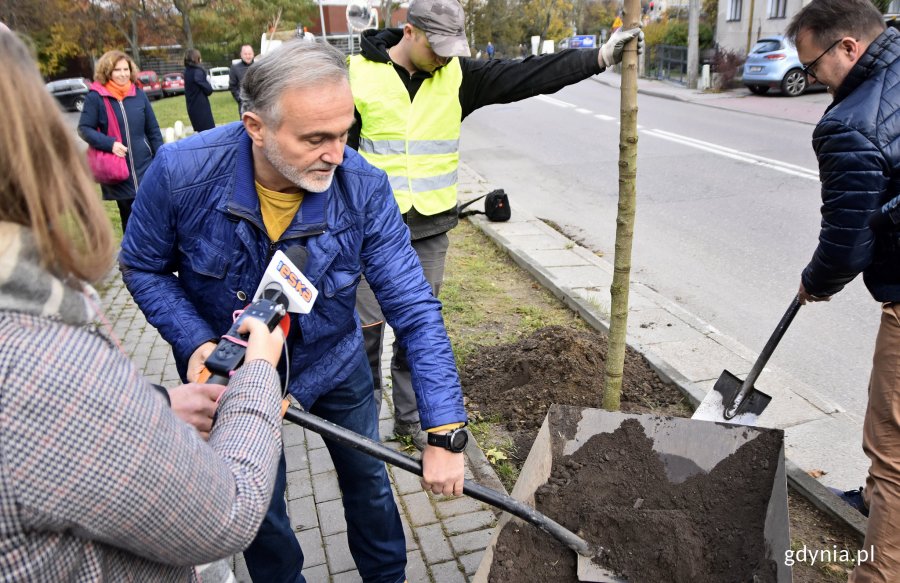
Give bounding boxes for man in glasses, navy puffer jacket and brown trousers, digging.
[787,0,900,583]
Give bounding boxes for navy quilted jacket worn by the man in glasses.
[802,28,900,302]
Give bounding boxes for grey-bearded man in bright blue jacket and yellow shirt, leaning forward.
[120,42,466,583]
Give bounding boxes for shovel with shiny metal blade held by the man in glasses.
[691,296,800,426]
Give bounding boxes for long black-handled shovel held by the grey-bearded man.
[282,401,626,583]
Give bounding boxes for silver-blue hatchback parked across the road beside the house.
[744,36,809,97]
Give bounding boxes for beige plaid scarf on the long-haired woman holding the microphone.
[0,221,100,326]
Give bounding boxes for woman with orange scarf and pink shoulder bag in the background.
[78,51,163,232]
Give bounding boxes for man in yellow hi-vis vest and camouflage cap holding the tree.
[347,0,643,449]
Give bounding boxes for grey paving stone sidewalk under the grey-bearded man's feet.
[100,271,502,583]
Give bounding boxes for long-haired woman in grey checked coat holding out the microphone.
[0,31,283,582]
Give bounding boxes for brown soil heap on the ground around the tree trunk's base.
[460,326,691,465]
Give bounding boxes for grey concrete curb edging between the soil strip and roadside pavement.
[460,215,868,540]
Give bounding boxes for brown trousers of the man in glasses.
[850,303,900,583]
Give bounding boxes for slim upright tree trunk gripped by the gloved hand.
[603,0,641,411]
